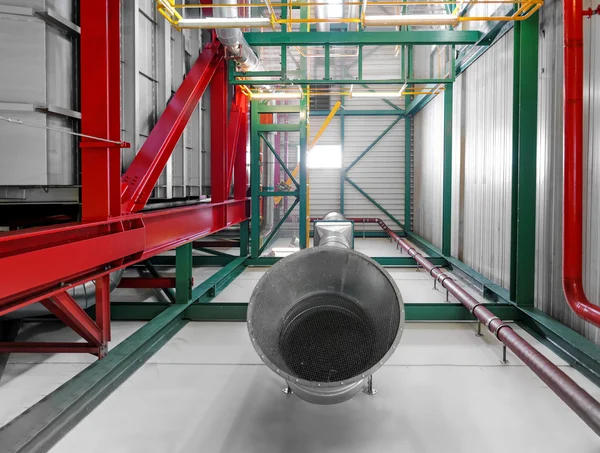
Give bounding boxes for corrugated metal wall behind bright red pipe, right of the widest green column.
[536,0,600,344]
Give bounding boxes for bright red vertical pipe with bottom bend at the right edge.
[563,0,600,327]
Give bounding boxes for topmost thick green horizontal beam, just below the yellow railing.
[244,30,481,47]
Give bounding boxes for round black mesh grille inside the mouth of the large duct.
[279,293,381,382]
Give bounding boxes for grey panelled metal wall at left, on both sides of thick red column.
[0,0,203,202]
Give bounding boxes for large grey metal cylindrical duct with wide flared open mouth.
[248,211,404,404]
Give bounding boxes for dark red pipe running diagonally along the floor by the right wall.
[377,219,600,436]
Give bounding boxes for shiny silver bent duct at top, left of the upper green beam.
[213,0,262,72]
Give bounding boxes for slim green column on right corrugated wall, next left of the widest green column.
[442,83,454,256]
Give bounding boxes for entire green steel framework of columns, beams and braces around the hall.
[0,14,600,452]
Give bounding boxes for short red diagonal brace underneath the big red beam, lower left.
[42,292,103,346]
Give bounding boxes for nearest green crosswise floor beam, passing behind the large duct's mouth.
[112,302,521,322]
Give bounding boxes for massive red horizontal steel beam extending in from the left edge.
[0,199,249,315]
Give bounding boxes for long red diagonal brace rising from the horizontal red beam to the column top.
[121,43,223,213]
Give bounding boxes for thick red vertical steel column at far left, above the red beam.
[80,0,121,220]
